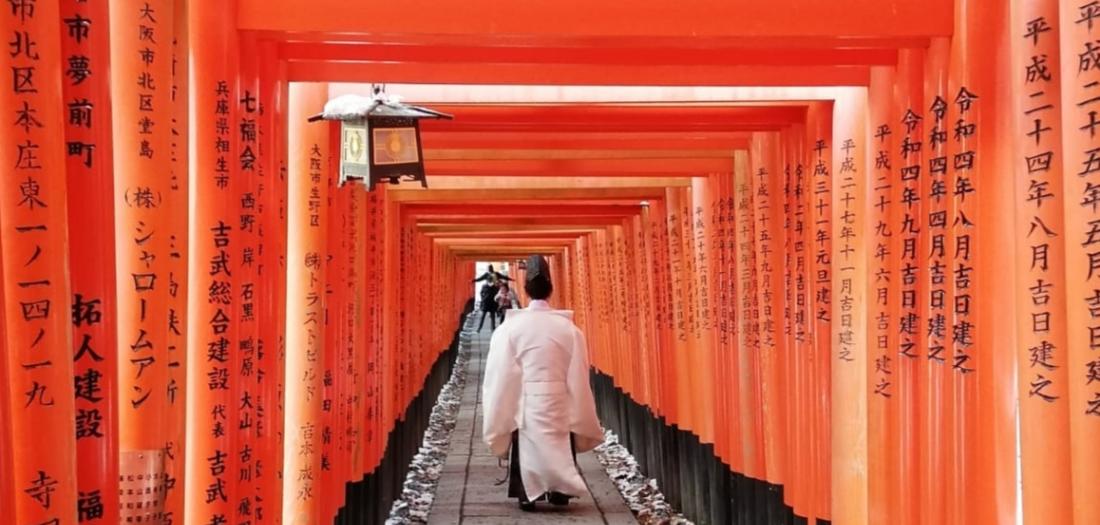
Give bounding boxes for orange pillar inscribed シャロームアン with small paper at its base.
[110,0,174,521]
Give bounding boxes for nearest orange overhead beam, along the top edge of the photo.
[237,0,954,43]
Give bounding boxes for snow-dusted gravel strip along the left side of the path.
[386,316,476,525]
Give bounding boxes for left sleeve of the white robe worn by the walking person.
[482,327,523,457]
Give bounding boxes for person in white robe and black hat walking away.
[482,255,604,511]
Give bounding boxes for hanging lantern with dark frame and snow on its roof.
[309,86,452,189]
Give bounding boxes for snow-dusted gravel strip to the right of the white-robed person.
[595,430,694,525]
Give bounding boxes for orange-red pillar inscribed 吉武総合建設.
[184,1,243,525]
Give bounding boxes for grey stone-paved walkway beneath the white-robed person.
[428,315,638,525]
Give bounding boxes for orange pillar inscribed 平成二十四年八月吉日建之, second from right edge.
[1010,0,1074,523]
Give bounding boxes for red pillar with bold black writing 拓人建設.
[61,1,119,525]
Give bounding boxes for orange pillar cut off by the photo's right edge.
[1056,0,1100,524]
